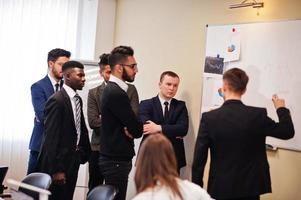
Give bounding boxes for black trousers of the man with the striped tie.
[49,159,80,200]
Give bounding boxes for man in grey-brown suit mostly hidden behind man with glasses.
[87,54,139,191]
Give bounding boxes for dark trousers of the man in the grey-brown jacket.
[88,151,104,192]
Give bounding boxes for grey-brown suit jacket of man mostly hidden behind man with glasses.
[87,82,139,151]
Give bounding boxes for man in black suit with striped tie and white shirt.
[38,61,91,200]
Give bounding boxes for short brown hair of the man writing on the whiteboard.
[223,68,249,94]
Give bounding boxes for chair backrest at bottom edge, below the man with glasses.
[87,185,117,200]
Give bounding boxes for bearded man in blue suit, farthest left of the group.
[27,49,70,174]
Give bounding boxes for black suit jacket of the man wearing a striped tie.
[38,88,91,175]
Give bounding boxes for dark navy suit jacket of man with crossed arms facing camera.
[139,96,188,168]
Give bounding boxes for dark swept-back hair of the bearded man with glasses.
[109,46,134,69]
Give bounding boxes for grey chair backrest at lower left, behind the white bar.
[19,172,51,200]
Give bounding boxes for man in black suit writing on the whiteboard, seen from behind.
[192,68,294,200]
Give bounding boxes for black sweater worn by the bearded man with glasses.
[100,82,143,160]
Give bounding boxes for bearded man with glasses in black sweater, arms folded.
[99,46,143,200]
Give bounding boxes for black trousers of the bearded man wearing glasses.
[99,155,132,200]
